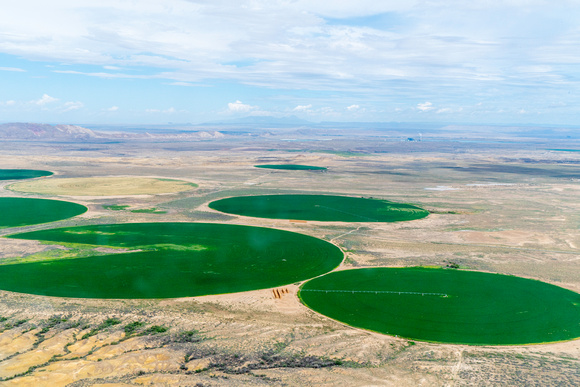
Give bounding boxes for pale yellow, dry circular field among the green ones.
[8,177,197,196]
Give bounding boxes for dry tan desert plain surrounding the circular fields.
[0,128,580,386]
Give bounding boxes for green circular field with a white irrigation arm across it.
[299,267,580,345]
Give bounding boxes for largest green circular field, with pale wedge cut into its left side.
[0,223,343,299]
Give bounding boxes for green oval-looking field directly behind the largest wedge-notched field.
[209,195,429,222]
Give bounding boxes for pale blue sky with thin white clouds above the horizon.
[0,0,580,125]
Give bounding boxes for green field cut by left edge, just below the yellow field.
[0,198,87,228]
